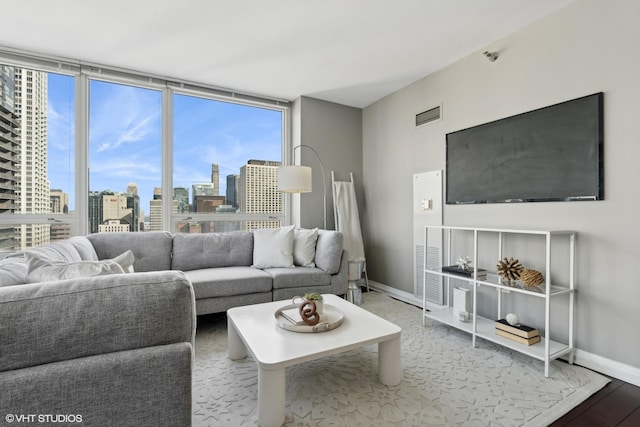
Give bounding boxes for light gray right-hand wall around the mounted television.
[362,0,640,383]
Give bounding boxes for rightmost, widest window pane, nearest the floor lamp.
[173,95,283,233]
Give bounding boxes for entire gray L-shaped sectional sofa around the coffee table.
[0,230,347,426]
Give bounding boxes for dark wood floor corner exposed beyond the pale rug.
[550,378,640,427]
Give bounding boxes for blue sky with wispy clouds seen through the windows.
[48,74,282,215]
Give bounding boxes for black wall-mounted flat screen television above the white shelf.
[446,92,604,204]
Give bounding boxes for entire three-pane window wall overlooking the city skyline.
[0,49,289,251]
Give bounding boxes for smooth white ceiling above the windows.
[0,0,574,107]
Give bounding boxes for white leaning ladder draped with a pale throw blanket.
[331,171,369,291]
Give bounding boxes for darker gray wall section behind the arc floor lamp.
[292,97,364,230]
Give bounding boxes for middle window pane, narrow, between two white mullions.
[89,80,162,233]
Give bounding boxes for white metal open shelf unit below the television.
[422,225,576,377]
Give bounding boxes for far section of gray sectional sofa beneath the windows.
[87,228,348,315]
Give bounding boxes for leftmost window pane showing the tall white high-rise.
[0,65,75,251]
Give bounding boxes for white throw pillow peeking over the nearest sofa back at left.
[25,250,134,283]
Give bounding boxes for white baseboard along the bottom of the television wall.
[369,280,640,387]
